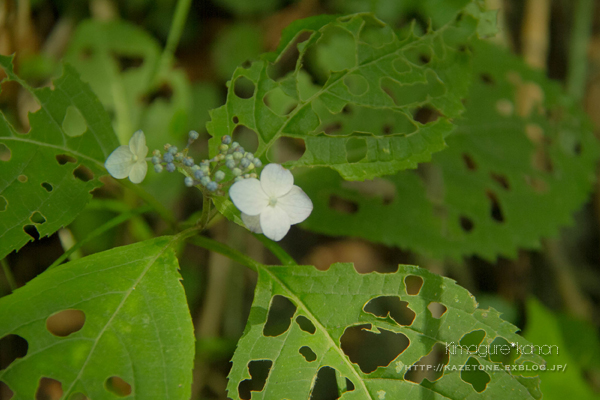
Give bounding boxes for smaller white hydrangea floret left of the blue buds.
[104,130,148,183]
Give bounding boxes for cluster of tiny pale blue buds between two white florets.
[152,131,262,192]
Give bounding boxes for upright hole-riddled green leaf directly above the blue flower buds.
[207,6,490,180]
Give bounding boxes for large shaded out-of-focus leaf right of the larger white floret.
[297,41,599,260]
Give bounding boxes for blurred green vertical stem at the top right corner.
[567,0,594,101]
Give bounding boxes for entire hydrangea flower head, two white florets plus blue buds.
[105,131,313,241]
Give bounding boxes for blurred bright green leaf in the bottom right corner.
[524,298,600,400]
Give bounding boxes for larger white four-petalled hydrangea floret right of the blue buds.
[229,164,313,241]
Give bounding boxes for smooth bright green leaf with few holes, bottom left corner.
[0,237,194,399]
